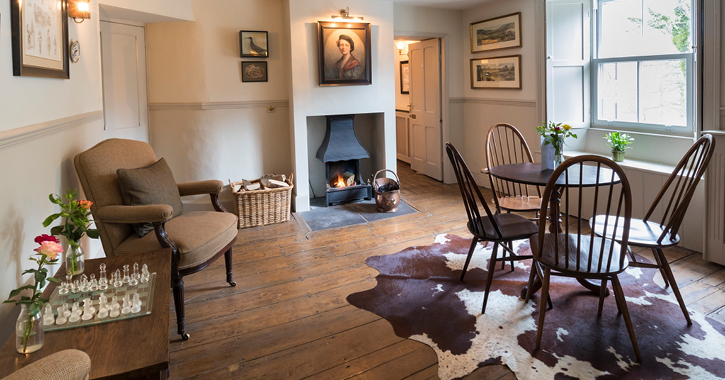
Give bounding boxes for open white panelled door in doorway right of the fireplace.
[408,38,443,181]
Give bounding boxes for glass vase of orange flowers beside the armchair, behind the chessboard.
[43,189,99,275]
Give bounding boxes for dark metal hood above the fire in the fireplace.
[316,115,370,162]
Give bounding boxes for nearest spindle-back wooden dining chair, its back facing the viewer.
[526,155,642,361]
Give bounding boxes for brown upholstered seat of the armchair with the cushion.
[115,211,237,270]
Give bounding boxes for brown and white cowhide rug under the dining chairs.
[347,235,725,379]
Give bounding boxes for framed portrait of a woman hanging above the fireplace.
[317,21,373,86]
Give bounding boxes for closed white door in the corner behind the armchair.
[101,21,149,142]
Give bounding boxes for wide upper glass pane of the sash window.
[598,0,692,58]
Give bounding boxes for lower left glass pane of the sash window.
[598,62,637,122]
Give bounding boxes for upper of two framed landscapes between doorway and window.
[471,12,521,53]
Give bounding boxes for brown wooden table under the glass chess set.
[0,249,171,379]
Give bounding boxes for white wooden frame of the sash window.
[590,0,699,137]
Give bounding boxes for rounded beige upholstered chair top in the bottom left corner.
[2,350,91,380]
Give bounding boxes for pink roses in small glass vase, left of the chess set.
[3,234,63,354]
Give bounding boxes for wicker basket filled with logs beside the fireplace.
[230,174,294,229]
